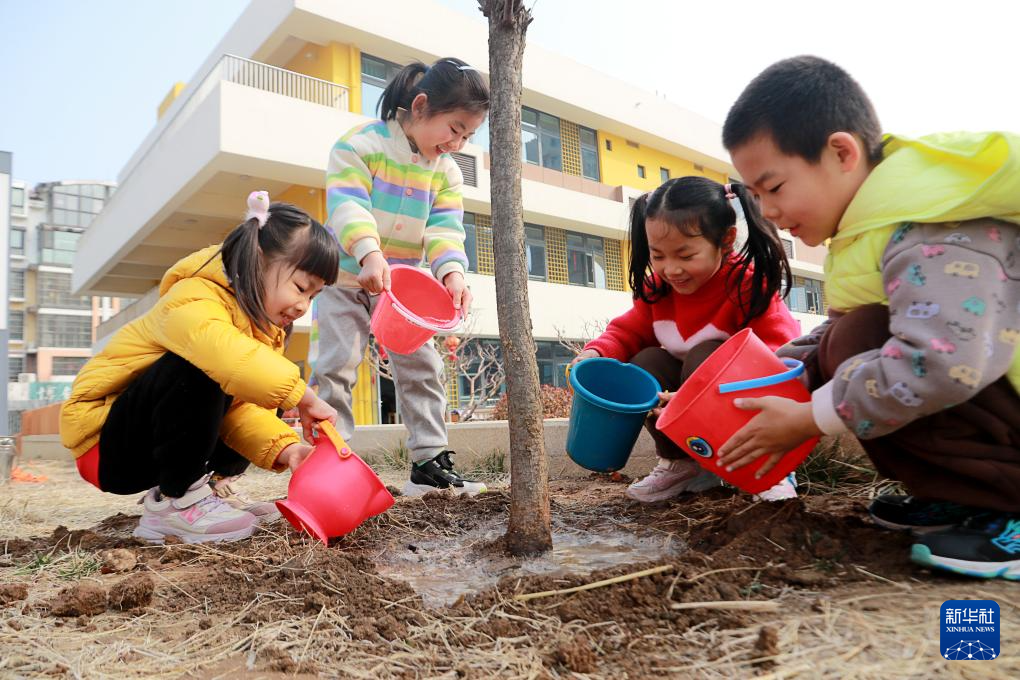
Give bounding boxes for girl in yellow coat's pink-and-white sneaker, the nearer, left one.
[134,475,257,543]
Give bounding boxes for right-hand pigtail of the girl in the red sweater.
[724,182,792,326]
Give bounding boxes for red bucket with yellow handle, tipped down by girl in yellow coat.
[276,421,393,543]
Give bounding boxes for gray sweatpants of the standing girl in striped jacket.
[313,285,448,463]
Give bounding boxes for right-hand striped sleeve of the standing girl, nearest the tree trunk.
[424,159,467,281]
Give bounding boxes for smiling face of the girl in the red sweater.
[645,218,736,295]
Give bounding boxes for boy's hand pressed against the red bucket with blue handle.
[717,397,822,479]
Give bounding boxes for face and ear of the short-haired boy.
[730,133,869,246]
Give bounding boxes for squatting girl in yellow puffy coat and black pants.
[60,192,340,542]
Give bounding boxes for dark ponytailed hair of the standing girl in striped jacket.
[378,57,489,120]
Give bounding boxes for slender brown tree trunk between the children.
[478,0,553,555]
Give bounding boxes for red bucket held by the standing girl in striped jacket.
[372,264,460,354]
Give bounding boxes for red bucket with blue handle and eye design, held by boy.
[656,328,818,493]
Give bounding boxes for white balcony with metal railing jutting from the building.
[71,55,364,297]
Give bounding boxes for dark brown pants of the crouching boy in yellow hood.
[805,305,1020,512]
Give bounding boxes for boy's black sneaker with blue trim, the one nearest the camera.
[910,513,1020,581]
